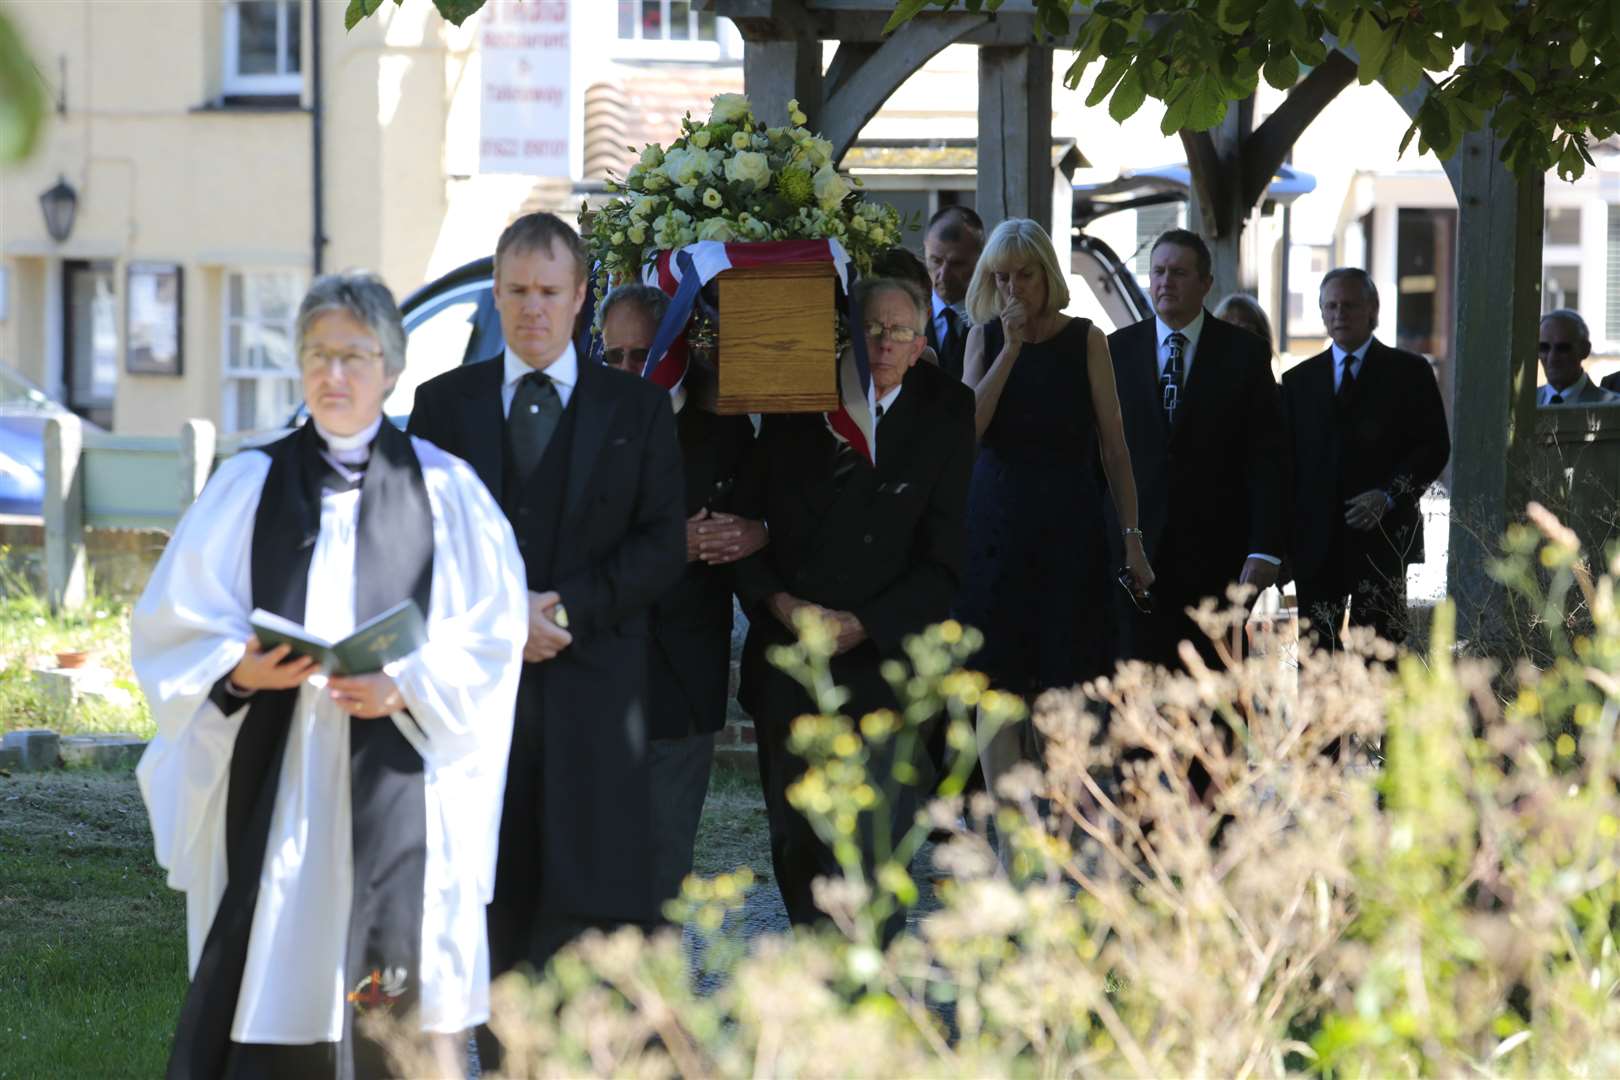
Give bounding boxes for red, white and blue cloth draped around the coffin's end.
[642,240,876,465]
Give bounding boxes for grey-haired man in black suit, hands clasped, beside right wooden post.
[1283,267,1452,646]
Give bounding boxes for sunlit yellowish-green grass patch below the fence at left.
[0,552,156,738]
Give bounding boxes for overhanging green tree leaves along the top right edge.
[888,0,1620,180]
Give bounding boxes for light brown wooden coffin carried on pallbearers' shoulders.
[693,262,839,415]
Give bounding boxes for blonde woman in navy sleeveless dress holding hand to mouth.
[957,219,1153,785]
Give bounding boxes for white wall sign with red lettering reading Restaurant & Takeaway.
[478,0,572,176]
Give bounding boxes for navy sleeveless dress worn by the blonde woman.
[957,319,1119,701]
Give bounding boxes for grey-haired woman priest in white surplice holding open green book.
[133,274,528,1078]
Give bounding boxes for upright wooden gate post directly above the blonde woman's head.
[975,45,1051,232]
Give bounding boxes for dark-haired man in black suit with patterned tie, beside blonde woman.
[1108,228,1286,667]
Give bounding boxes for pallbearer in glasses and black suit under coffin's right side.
[737,279,974,931]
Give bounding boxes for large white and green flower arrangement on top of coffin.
[580,94,902,295]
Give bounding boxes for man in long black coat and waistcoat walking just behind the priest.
[410,214,685,975]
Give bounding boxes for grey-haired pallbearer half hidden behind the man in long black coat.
[601,285,766,899]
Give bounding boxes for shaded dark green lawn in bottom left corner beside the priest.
[0,771,186,1080]
